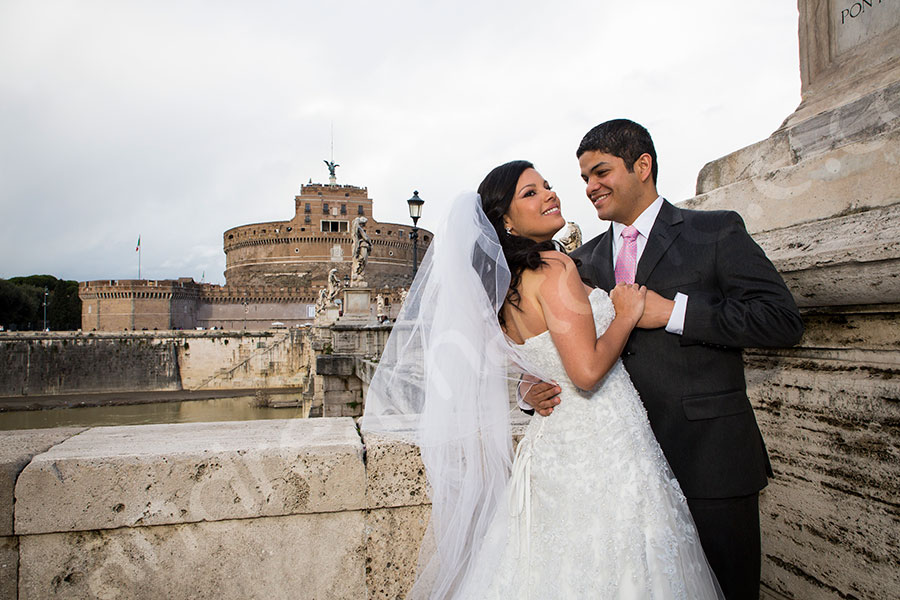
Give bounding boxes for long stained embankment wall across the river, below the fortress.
[0,328,313,397]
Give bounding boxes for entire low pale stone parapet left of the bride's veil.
[0,418,430,600]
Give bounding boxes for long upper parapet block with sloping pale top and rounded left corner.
[15,419,365,535]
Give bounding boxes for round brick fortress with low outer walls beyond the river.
[79,169,432,331]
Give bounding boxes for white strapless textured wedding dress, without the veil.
[456,290,721,600]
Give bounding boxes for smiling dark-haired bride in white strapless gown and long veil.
[361,161,721,600]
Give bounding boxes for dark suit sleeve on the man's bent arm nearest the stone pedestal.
[683,212,803,348]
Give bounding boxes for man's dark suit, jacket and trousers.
[572,202,803,597]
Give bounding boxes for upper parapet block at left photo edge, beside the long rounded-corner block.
[0,427,85,536]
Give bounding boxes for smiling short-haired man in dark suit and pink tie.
[525,119,803,600]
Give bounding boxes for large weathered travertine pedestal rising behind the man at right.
[686,0,900,600]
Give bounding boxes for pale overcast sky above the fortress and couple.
[0,0,800,283]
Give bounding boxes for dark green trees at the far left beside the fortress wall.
[0,275,81,331]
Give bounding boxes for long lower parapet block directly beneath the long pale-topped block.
[19,511,366,600]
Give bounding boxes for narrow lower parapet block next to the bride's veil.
[366,505,431,600]
